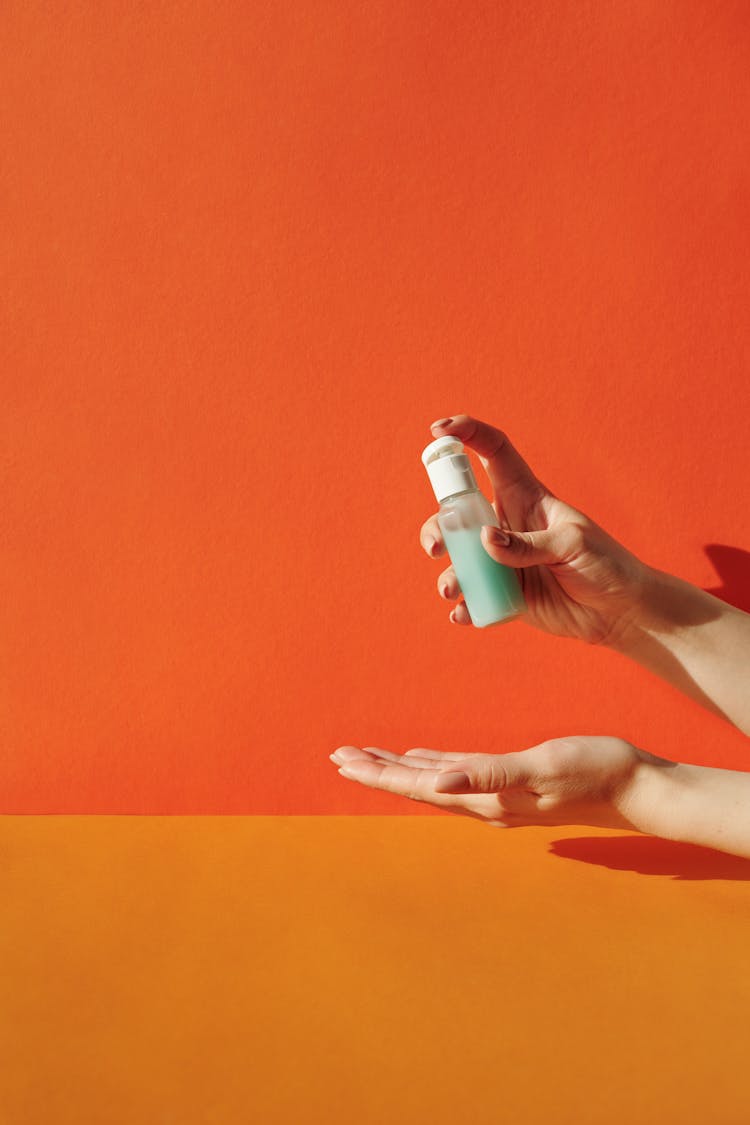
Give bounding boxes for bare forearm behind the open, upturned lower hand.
[620,752,750,858]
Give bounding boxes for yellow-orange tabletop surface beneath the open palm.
[0,816,750,1125]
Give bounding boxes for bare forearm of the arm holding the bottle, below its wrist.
[611,567,750,735]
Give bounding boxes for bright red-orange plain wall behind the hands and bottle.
[0,0,750,816]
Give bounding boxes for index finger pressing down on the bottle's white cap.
[431,414,548,522]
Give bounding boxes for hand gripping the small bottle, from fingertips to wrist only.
[419,414,649,644]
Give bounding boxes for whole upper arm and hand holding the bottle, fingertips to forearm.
[419,414,750,735]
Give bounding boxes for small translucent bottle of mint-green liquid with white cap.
[422,437,526,629]
